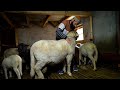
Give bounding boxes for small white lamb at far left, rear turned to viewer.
[2,55,22,79]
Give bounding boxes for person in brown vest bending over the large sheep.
[56,17,80,74]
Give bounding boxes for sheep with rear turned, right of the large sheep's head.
[79,42,98,70]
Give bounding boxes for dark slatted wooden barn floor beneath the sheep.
[0,61,120,79]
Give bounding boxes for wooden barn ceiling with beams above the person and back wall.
[0,11,91,28]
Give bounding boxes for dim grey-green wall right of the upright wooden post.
[93,11,118,53]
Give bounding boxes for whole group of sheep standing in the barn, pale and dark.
[2,31,98,79]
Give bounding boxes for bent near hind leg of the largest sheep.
[35,61,45,79]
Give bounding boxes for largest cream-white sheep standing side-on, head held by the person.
[30,31,78,79]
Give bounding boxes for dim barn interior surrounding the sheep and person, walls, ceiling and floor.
[0,11,120,79]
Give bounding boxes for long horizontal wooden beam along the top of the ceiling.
[4,11,91,17]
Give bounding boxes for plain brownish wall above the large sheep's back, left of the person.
[16,23,56,45]
